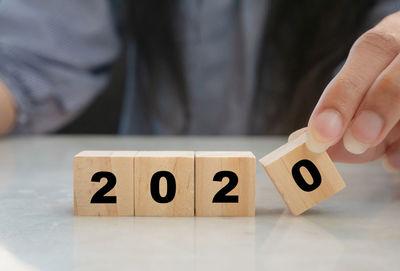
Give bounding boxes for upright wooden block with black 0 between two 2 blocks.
[135,151,194,216]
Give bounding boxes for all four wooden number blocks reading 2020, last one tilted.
[74,134,345,216]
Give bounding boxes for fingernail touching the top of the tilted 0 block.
[306,109,342,152]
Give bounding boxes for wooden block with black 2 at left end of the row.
[74,151,137,216]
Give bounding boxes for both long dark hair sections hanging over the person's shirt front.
[126,0,375,134]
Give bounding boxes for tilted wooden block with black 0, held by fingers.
[260,134,346,215]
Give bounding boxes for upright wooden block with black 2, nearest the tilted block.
[195,152,256,216]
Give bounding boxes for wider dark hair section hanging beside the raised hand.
[251,0,375,134]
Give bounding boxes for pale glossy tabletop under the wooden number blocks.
[0,136,400,270]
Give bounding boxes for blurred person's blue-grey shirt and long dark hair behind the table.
[0,0,398,135]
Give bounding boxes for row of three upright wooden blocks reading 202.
[74,151,255,216]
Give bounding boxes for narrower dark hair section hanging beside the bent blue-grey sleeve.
[125,0,190,133]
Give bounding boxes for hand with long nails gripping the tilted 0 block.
[307,12,400,170]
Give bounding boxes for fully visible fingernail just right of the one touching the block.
[343,111,383,154]
